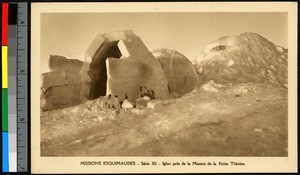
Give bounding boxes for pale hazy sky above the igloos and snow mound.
[41,12,288,72]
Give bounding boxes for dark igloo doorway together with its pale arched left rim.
[80,30,133,101]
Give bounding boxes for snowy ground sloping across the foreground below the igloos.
[41,83,288,156]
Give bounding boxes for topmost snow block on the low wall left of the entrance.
[48,55,83,72]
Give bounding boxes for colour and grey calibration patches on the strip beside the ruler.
[2,3,18,172]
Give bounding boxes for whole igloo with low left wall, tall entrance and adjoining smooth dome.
[41,30,198,110]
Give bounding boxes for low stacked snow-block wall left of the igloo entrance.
[40,55,83,110]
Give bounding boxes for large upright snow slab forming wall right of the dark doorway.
[106,58,169,101]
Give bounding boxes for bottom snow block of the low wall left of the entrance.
[41,85,81,111]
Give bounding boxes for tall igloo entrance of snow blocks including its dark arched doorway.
[80,30,169,101]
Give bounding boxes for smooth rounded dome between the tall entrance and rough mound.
[152,48,198,95]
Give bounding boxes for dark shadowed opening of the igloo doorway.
[89,41,122,100]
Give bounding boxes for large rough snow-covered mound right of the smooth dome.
[194,32,288,88]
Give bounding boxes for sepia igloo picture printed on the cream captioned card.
[32,1,296,174]
